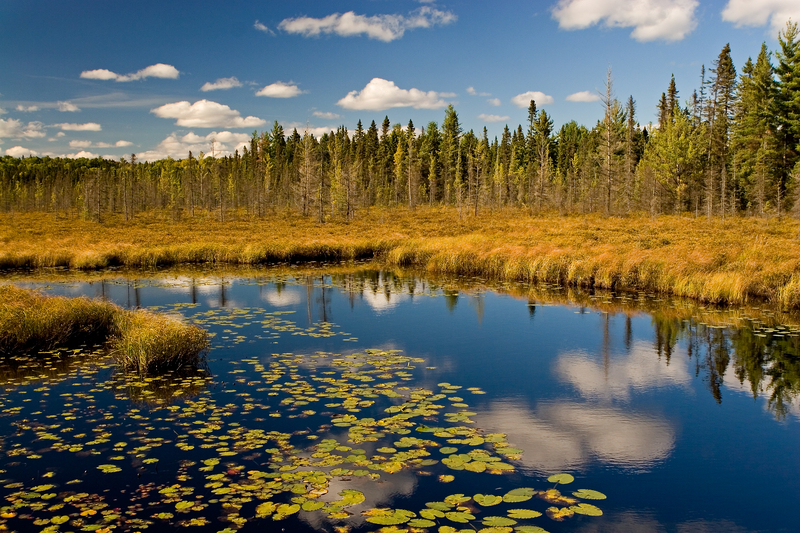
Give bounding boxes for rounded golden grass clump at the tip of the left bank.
[111,309,208,373]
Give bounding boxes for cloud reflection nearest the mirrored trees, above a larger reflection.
[555,342,692,399]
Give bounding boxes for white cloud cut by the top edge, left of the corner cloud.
[552,0,696,41]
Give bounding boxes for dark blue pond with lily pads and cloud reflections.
[0,267,800,533]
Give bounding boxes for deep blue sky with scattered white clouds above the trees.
[0,0,800,160]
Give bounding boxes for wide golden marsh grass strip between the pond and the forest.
[0,207,800,309]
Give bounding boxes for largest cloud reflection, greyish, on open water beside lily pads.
[477,401,675,473]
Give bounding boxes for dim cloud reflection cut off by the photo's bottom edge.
[575,511,750,533]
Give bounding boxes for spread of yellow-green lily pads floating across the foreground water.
[0,290,605,533]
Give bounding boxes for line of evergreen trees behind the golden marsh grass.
[0,22,800,222]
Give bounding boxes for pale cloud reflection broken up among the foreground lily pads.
[300,471,417,530]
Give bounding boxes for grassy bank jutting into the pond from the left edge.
[0,285,208,373]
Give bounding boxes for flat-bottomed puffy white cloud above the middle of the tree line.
[337,78,447,111]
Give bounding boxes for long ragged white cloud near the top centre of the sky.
[278,6,458,43]
